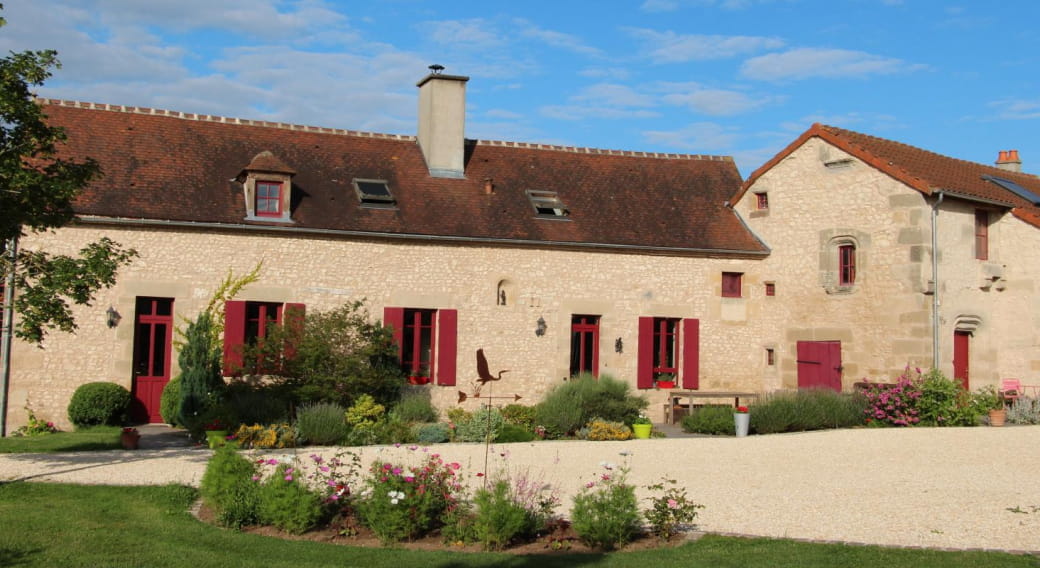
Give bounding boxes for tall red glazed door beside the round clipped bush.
[130,298,174,422]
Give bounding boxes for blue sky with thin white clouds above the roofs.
[0,0,1040,176]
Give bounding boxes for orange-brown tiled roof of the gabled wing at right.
[733,124,1040,227]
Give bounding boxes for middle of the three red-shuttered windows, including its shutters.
[383,308,459,386]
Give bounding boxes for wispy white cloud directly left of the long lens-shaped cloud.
[627,28,784,63]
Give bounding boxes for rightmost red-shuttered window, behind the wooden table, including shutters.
[635,317,701,389]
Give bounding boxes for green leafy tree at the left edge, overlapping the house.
[0,4,137,343]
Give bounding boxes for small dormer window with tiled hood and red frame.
[235,151,296,223]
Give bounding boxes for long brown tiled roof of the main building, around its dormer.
[42,100,768,255]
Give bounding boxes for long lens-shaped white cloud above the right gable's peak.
[740,48,926,81]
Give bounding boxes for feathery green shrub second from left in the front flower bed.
[257,464,324,535]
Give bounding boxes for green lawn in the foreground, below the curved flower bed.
[0,483,1040,568]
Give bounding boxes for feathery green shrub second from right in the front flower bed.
[571,467,641,550]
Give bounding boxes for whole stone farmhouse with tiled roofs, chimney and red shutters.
[7,73,1040,428]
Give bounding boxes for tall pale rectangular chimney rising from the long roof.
[416,66,469,178]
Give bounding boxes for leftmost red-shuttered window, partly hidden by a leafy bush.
[224,300,305,377]
